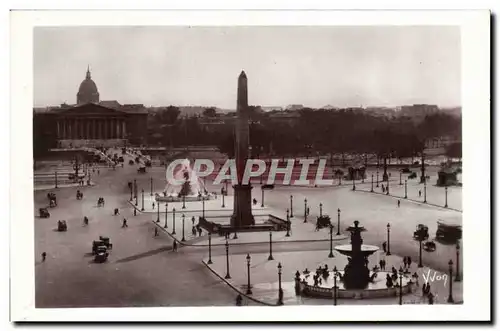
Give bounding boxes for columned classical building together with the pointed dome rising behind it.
[33,70,148,148]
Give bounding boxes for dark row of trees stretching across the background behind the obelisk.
[148,106,461,157]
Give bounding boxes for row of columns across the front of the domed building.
[57,117,127,139]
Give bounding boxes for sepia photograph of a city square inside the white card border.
[11,9,490,321]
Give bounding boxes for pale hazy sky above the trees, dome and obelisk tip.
[34,26,461,108]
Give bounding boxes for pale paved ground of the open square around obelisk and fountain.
[34,148,463,307]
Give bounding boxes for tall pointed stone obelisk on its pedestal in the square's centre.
[231,71,255,228]
